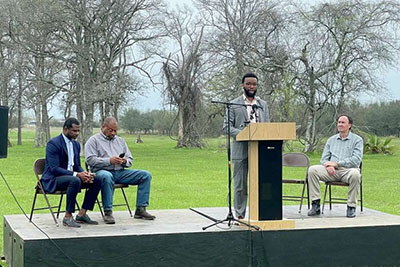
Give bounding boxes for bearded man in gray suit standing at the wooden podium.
[224,73,269,219]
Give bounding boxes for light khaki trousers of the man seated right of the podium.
[308,165,361,208]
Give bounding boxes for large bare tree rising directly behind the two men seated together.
[54,0,164,143]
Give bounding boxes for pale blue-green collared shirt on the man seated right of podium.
[321,132,364,168]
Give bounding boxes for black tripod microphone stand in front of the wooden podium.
[190,101,260,231]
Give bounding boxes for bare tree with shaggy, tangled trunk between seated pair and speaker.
[160,9,206,147]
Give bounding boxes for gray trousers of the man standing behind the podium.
[232,158,249,218]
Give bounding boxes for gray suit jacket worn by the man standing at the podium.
[224,95,269,160]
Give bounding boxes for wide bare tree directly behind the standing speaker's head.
[195,0,290,125]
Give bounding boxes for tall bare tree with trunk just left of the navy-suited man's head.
[9,1,63,146]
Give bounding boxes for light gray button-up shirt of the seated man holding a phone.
[85,131,133,172]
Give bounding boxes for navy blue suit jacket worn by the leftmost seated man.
[42,134,83,193]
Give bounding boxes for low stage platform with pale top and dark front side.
[3,205,400,267]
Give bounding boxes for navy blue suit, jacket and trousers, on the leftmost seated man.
[41,134,104,213]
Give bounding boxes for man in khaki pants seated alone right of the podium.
[308,115,364,218]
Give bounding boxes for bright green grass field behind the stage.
[0,129,400,260]
